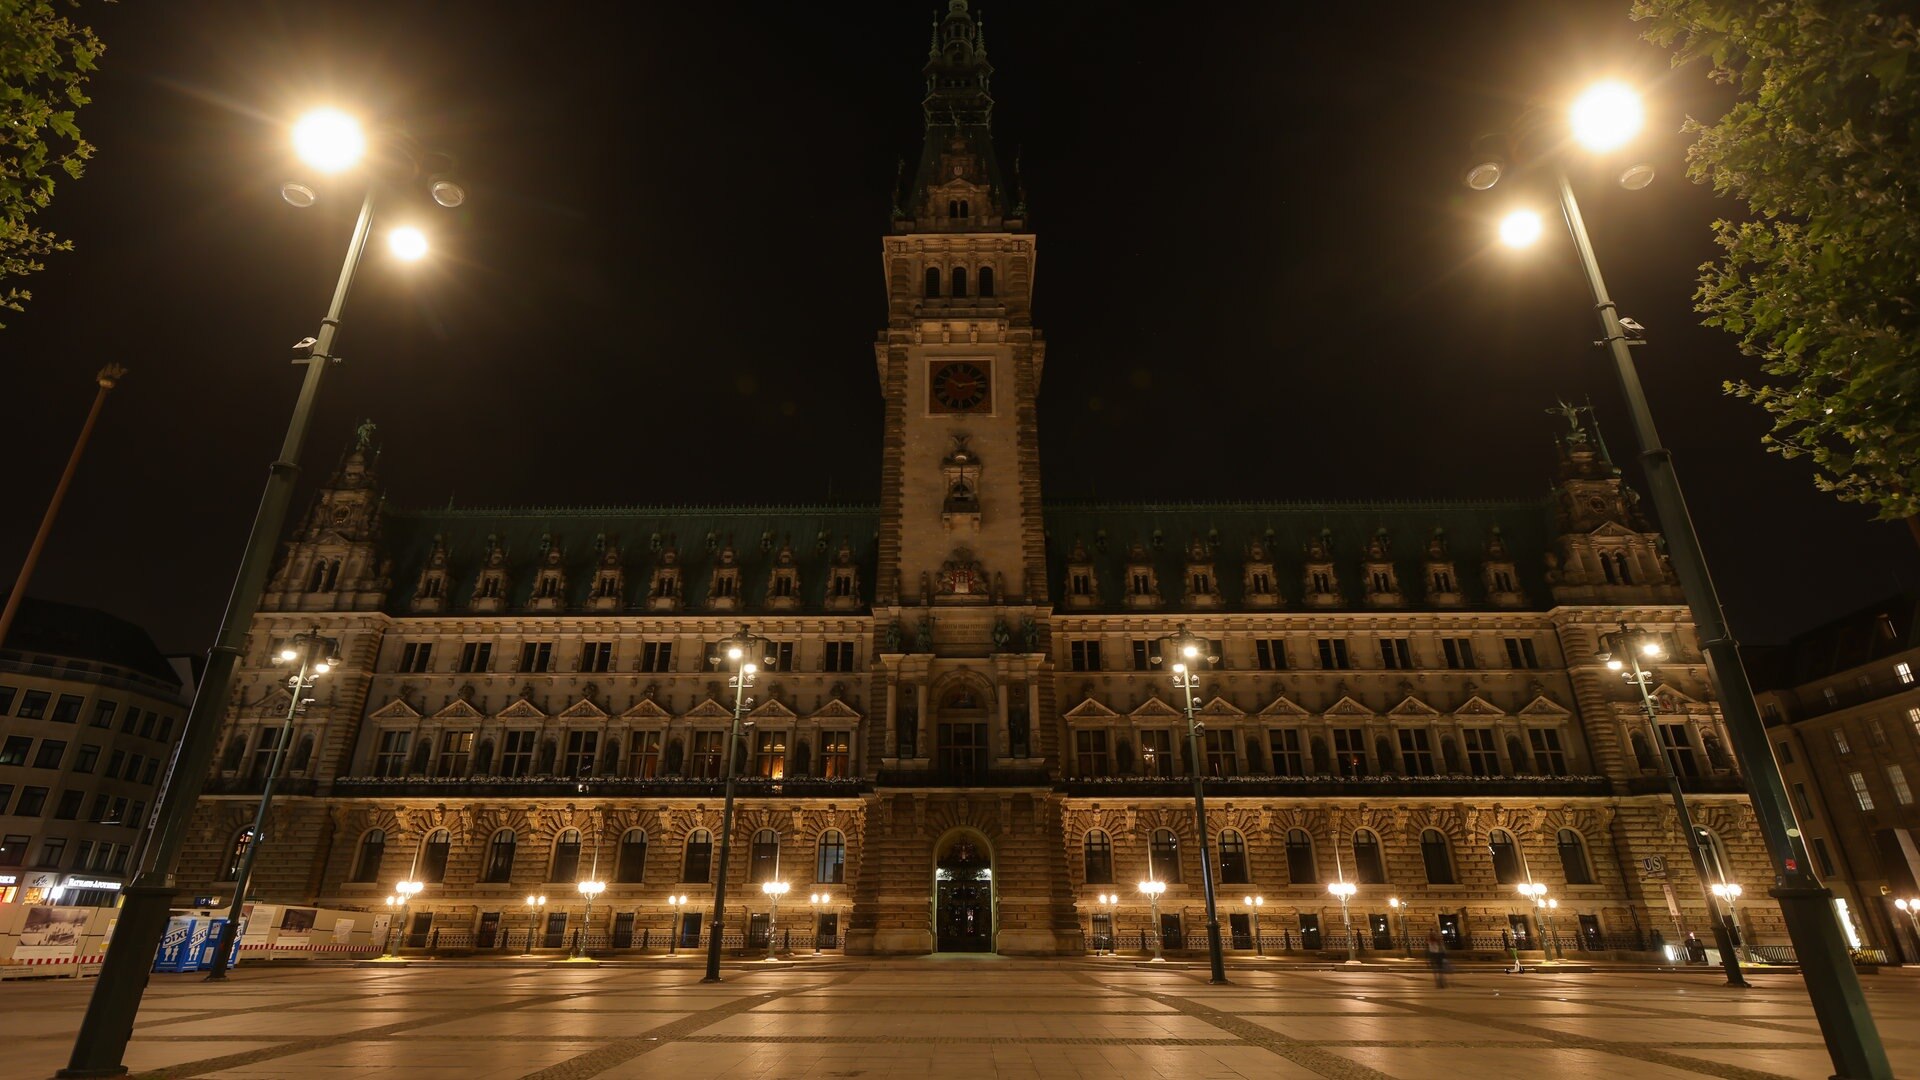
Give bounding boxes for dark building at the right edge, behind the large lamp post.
[1755,596,1920,961]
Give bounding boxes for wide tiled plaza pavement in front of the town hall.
[0,957,1920,1080]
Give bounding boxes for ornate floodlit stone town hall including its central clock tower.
[168,0,1776,955]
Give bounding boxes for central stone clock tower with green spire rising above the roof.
[874,0,1046,611]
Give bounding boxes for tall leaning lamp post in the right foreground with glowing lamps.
[1463,83,1893,1080]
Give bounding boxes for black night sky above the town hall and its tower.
[0,0,1920,651]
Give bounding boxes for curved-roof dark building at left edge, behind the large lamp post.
[0,596,186,905]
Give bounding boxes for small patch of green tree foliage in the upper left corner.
[0,0,104,326]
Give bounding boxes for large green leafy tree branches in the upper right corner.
[1632,0,1920,519]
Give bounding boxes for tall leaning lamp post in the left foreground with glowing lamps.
[60,110,467,1076]
